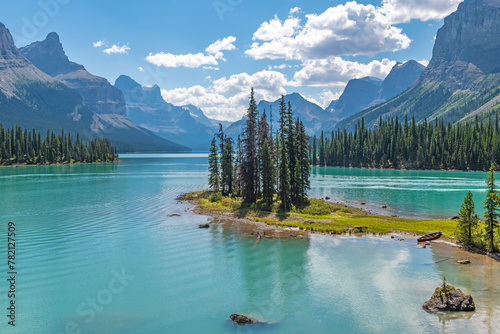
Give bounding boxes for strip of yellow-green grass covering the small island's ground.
[184,192,457,239]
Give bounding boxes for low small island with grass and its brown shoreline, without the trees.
[179,190,457,239]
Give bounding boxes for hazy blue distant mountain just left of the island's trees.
[115,75,218,151]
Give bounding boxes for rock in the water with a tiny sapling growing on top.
[422,287,476,312]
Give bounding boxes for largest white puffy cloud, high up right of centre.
[245,1,411,60]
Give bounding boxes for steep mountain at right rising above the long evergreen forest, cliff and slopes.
[338,0,500,129]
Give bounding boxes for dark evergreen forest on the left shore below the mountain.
[0,124,118,166]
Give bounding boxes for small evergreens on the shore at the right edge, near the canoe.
[456,164,500,252]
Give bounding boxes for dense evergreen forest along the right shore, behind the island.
[311,115,500,171]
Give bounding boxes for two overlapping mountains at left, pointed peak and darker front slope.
[0,23,190,152]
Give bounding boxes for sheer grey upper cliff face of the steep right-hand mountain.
[421,0,500,90]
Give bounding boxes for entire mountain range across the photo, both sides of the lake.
[0,0,500,152]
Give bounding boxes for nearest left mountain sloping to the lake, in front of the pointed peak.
[0,23,188,152]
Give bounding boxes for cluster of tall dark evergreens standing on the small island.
[208,88,310,211]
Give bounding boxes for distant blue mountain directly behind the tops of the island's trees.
[226,93,331,138]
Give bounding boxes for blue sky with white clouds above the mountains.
[0,0,462,121]
